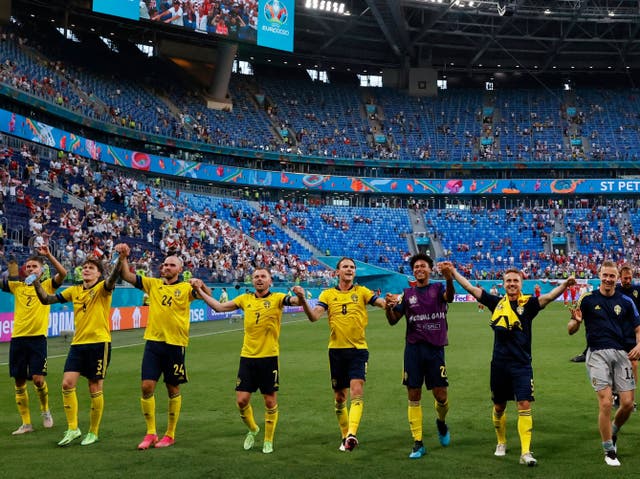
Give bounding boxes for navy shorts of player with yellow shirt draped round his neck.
[490,361,535,404]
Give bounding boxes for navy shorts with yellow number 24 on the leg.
[142,341,188,386]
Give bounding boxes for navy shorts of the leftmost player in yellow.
[9,336,47,379]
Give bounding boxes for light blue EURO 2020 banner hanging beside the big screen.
[258,0,295,52]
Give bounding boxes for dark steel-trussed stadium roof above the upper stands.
[14,0,640,77]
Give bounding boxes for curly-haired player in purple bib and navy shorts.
[385,253,455,459]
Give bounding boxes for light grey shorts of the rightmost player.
[586,349,636,392]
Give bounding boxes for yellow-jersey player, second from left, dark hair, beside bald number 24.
[34,257,120,446]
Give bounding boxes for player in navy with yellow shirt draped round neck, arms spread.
[453,269,575,466]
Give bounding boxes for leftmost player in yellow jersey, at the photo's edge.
[1,246,67,435]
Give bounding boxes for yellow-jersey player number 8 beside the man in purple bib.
[296,258,387,451]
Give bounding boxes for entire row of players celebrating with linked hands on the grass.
[1,243,640,466]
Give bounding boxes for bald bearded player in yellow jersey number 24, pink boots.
[115,243,210,450]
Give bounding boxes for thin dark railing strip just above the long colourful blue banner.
[5,83,640,170]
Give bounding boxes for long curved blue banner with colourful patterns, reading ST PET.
[0,109,640,196]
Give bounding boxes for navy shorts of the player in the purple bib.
[402,343,449,389]
